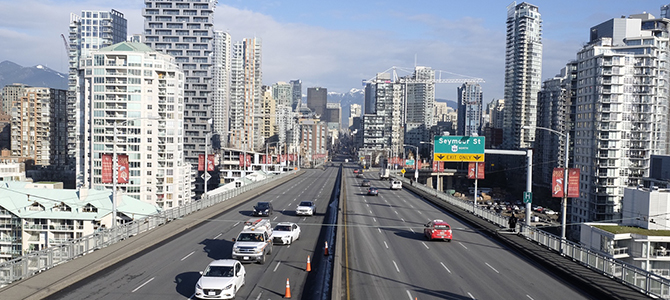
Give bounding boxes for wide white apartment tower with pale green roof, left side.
[79,42,192,208]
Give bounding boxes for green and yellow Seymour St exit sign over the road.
[433,136,485,162]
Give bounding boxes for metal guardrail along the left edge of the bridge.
[0,171,295,287]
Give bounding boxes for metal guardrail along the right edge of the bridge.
[393,175,670,299]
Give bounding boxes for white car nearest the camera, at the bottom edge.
[195,259,246,299]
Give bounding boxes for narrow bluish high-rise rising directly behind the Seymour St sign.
[456,83,484,136]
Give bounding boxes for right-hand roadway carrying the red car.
[343,164,588,300]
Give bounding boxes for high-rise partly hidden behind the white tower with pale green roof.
[67,10,128,187]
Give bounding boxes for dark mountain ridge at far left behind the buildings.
[0,60,67,90]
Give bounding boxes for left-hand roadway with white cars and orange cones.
[50,168,339,300]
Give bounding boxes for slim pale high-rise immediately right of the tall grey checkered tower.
[212,30,232,143]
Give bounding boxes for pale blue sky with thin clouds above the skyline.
[0,0,670,102]
